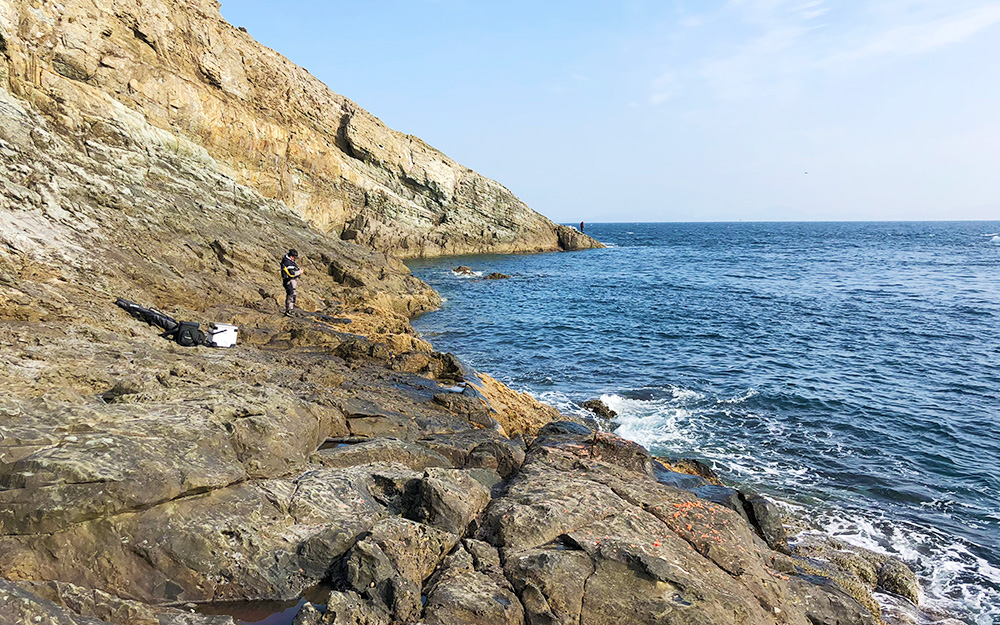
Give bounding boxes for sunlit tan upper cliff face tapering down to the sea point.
[0,0,600,257]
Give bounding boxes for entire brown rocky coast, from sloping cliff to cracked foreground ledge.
[0,0,919,625]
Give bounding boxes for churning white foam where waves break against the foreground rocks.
[601,387,1000,625]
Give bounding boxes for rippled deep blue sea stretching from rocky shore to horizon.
[410,222,1000,625]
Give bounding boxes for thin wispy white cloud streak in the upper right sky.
[646,0,1000,105]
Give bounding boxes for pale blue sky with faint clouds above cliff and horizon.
[222,0,1000,223]
